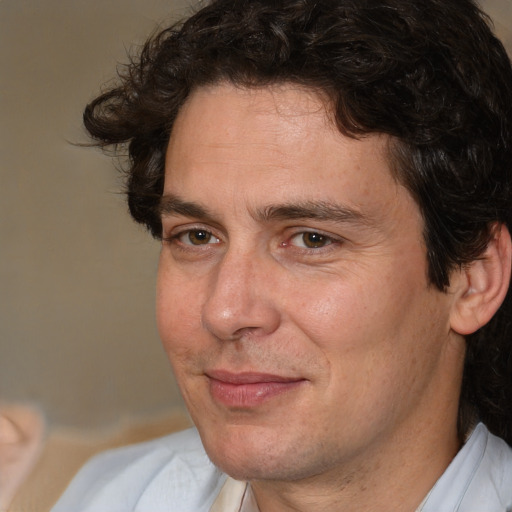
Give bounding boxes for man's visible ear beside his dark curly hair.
[450,224,512,335]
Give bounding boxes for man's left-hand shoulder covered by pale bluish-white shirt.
[52,429,225,512]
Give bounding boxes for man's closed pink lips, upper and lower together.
[206,370,306,409]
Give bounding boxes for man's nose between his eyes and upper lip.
[202,251,280,341]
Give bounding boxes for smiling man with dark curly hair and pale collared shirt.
[54,0,512,512]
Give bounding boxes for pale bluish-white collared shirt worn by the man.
[52,424,512,512]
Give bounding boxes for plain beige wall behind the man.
[0,0,512,427]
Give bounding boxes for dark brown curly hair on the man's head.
[84,0,512,444]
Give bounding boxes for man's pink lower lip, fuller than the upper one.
[210,378,304,409]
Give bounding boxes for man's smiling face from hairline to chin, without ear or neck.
[157,84,458,480]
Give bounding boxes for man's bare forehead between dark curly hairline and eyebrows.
[164,83,416,221]
